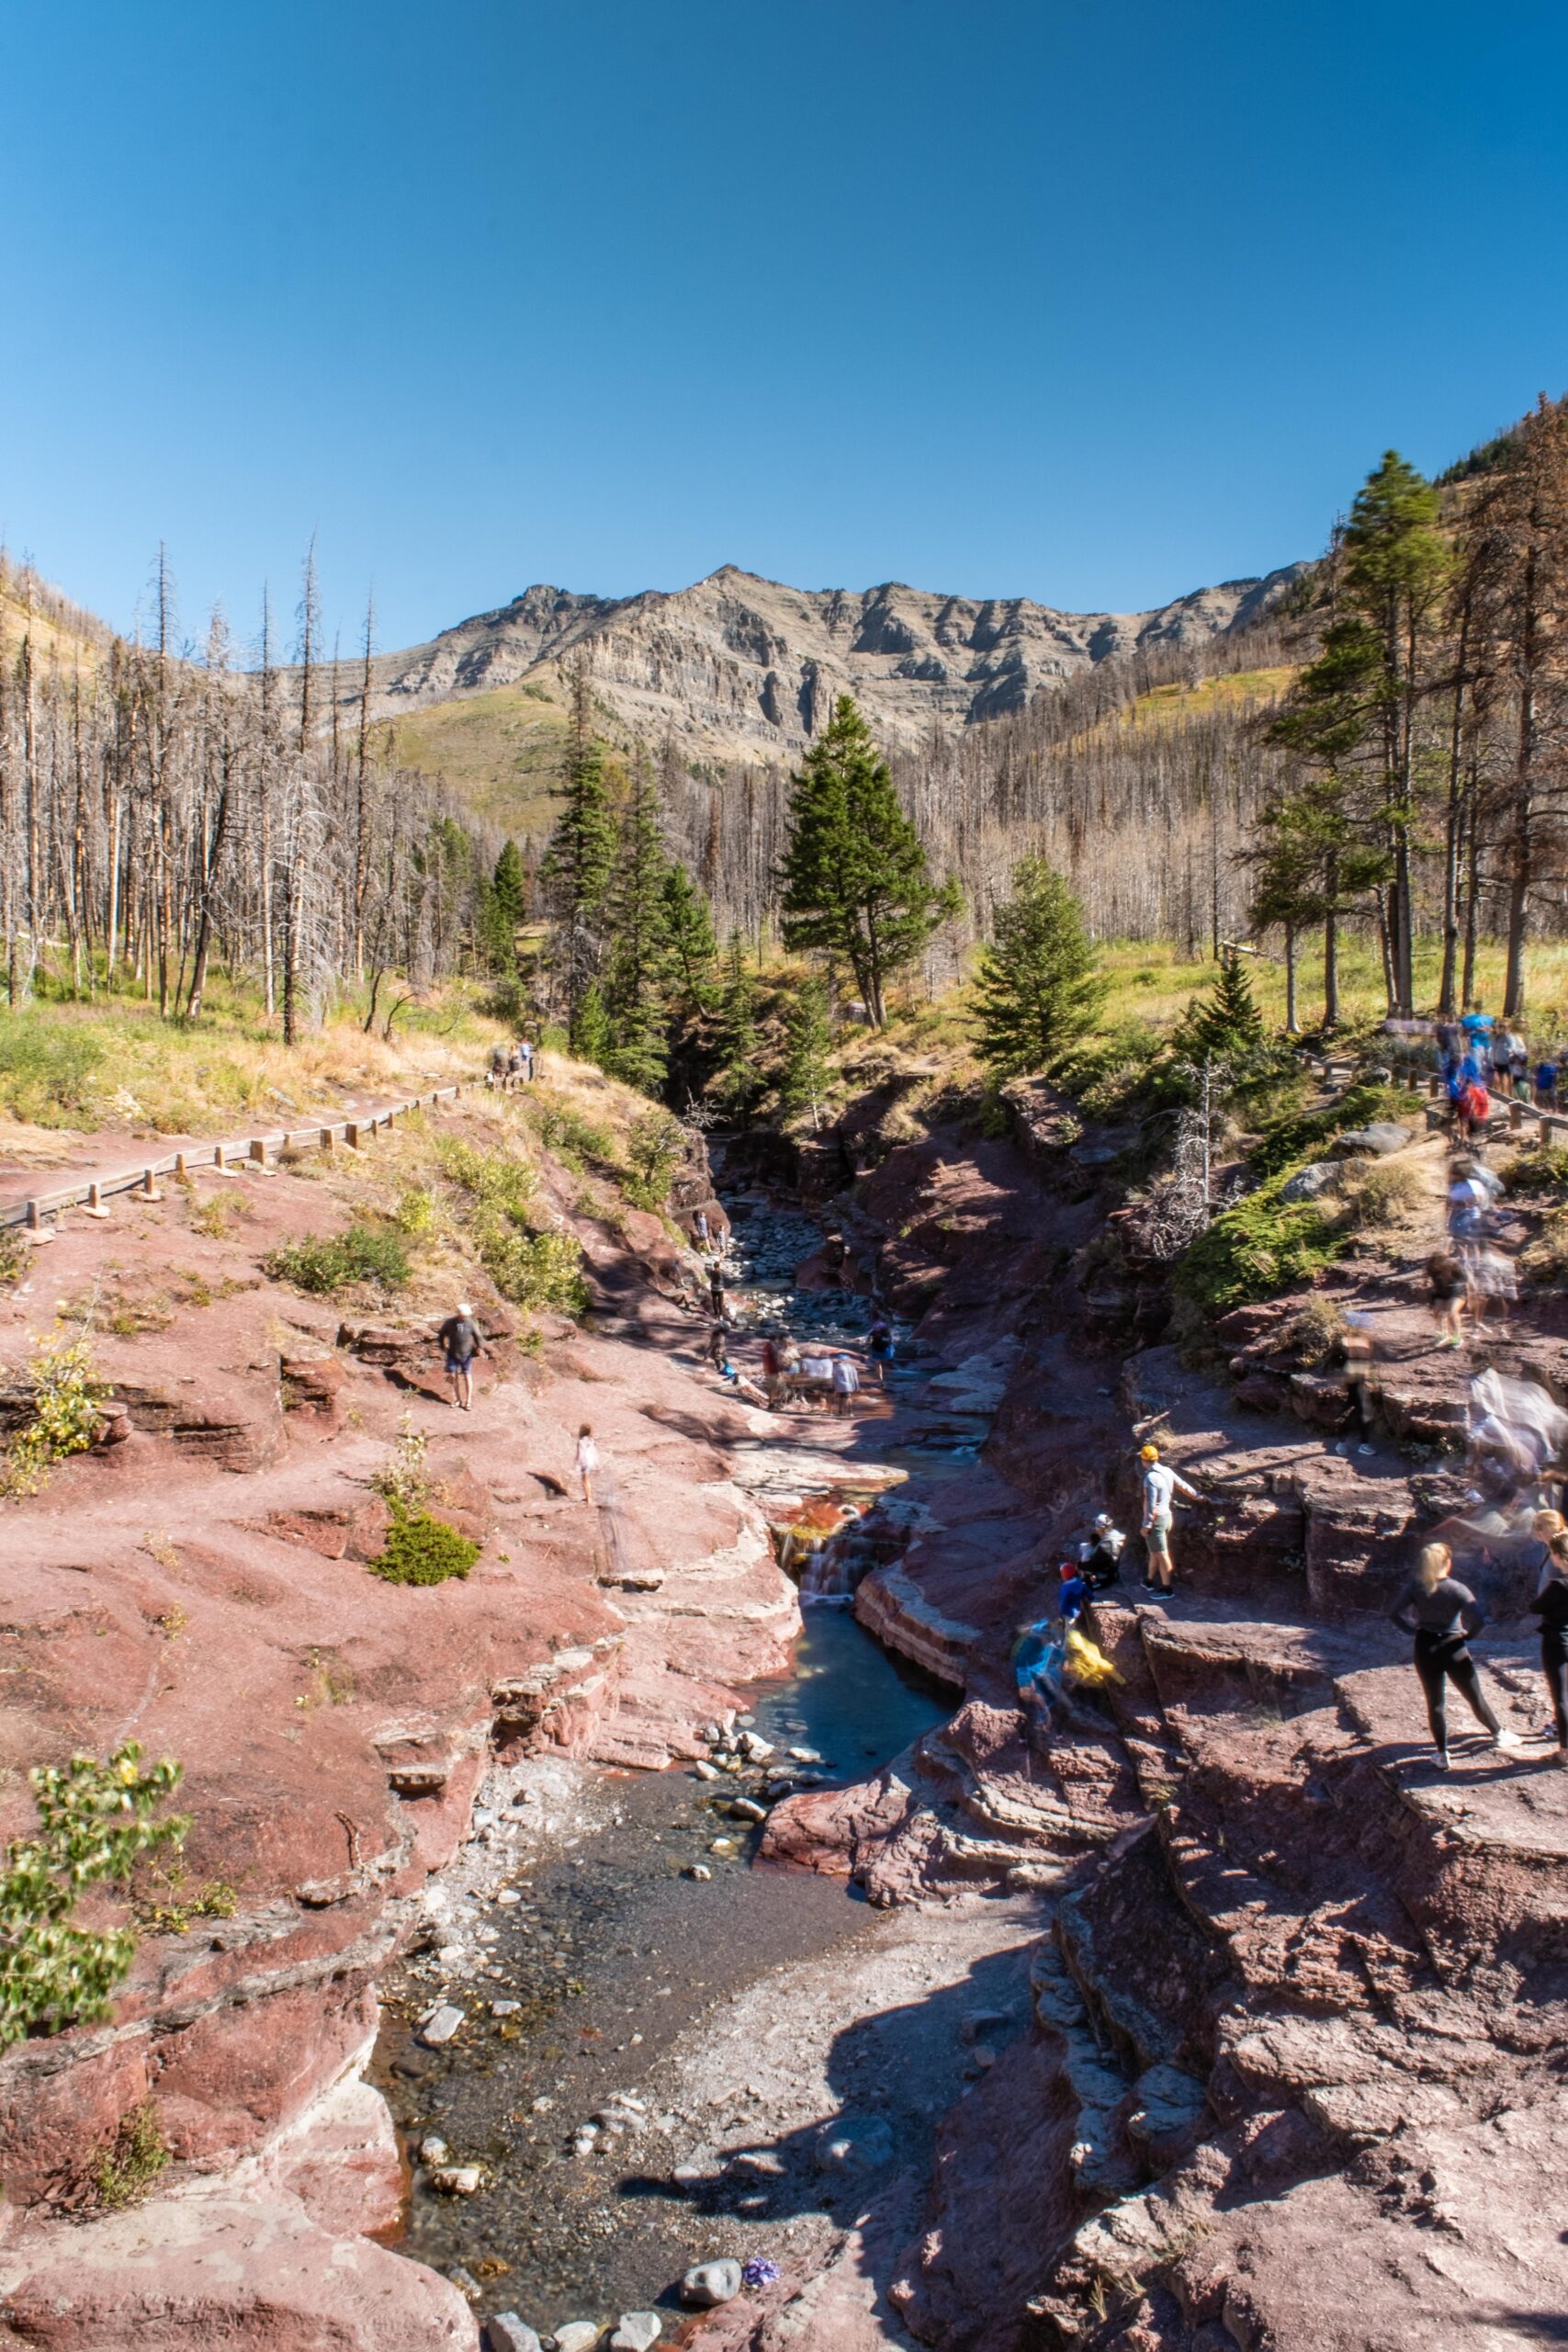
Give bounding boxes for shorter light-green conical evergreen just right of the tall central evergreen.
[976,858,1105,1077]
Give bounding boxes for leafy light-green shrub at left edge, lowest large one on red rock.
[0,1740,188,2049]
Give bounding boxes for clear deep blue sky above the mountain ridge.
[0,0,1568,647]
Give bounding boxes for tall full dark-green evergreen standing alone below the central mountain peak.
[781,694,957,1028]
